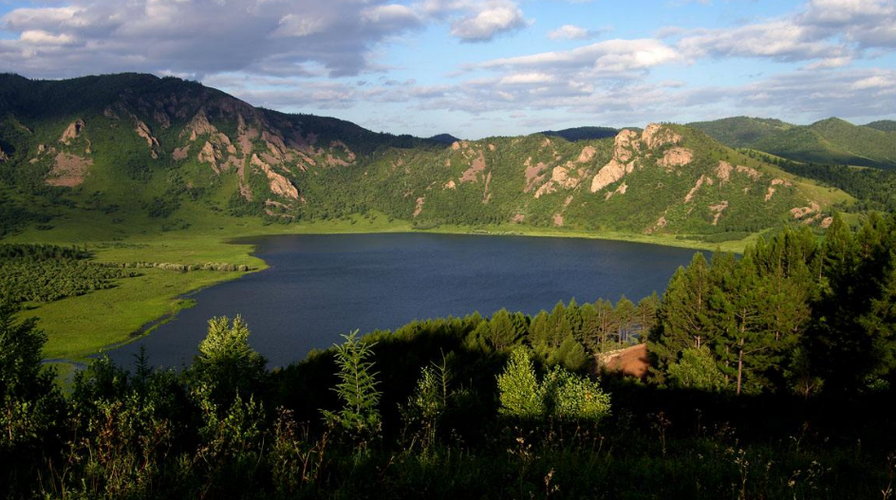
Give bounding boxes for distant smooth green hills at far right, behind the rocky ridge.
[690,117,896,168]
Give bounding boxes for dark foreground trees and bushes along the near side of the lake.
[0,216,896,499]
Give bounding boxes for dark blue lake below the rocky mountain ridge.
[109,233,694,367]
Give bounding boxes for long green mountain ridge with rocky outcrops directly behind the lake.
[0,74,849,242]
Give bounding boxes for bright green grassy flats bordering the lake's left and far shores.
[5,200,758,376]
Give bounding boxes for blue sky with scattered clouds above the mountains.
[0,0,896,139]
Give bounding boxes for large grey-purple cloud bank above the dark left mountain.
[0,0,424,77]
